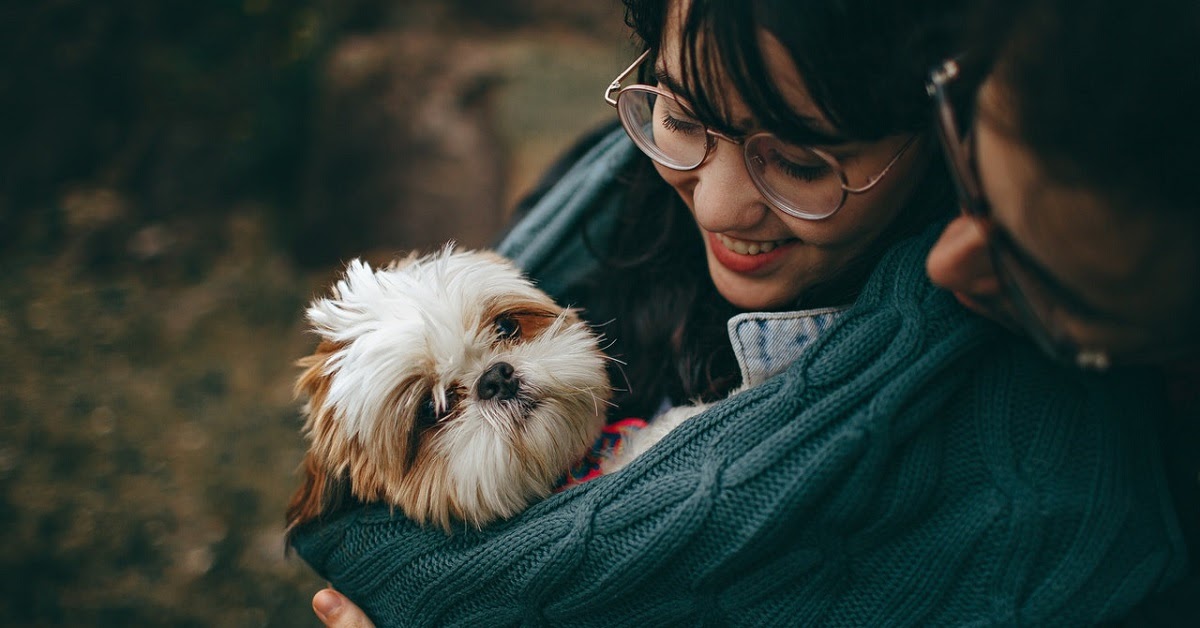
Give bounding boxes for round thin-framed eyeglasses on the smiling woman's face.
[604,50,917,220]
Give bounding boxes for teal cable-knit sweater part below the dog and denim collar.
[294,130,1186,627]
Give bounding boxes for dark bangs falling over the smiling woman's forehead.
[624,0,961,145]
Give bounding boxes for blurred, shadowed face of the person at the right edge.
[928,79,1200,359]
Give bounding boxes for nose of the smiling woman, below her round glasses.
[692,139,770,233]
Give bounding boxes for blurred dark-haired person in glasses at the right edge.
[928,0,1200,626]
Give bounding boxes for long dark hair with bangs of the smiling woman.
[581,0,959,415]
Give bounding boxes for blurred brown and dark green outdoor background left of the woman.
[0,0,637,627]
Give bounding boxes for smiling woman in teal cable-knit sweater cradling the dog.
[295,0,1183,626]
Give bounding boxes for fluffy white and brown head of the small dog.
[288,247,610,531]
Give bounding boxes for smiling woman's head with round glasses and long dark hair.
[506,0,956,425]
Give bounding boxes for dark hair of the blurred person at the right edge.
[966,0,1200,216]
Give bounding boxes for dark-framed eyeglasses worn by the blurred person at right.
[925,59,1111,370]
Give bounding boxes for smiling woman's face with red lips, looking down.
[655,20,925,311]
